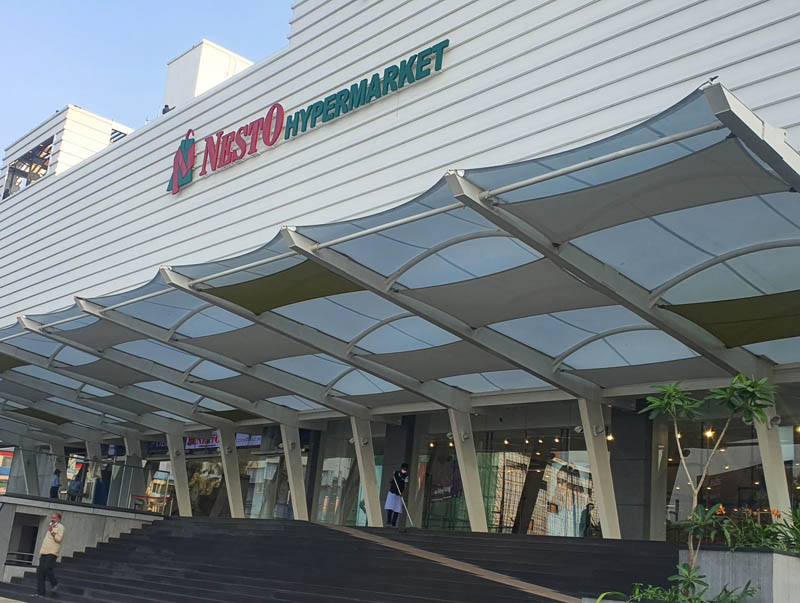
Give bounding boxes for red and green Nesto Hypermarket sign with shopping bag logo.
[167,40,450,195]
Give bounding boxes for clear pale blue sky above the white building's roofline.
[0,0,291,153]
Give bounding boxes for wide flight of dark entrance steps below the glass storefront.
[0,518,678,603]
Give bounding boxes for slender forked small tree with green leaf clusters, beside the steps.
[641,373,775,570]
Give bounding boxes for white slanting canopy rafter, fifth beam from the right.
[75,297,372,419]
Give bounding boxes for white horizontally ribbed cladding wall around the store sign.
[0,0,800,325]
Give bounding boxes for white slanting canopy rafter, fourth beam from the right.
[160,266,471,410]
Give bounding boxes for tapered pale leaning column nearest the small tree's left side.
[578,398,621,538]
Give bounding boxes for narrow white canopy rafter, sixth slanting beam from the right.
[19,316,297,425]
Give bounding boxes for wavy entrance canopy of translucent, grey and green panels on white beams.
[0,85,800,444]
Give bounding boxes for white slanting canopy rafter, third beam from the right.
[281,227,600,398]
